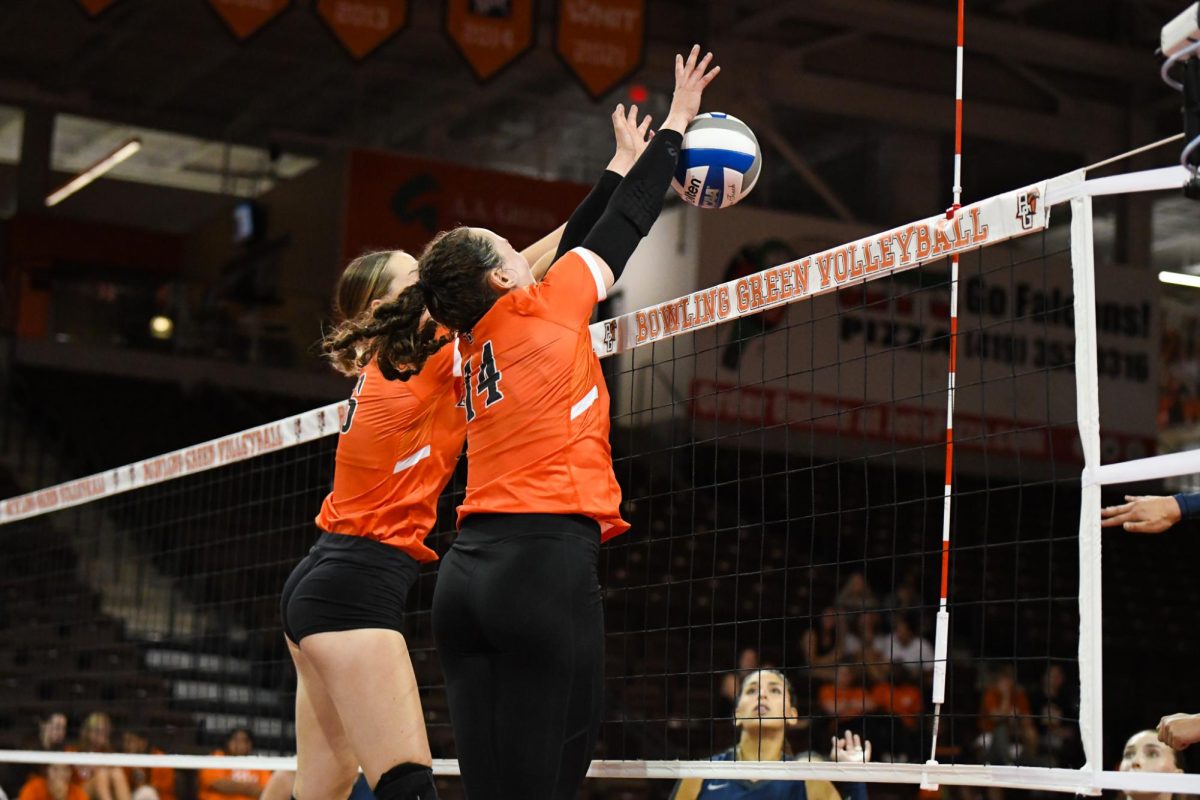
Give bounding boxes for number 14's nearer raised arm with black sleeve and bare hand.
[583,44,721,289]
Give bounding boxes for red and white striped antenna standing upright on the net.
[922,0,965,789]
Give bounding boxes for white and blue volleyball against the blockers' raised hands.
[671,113,762,209]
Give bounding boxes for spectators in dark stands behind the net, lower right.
[716,572,1082,768]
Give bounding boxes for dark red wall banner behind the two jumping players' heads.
[342,150,588,271]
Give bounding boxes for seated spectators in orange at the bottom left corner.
[0,711,271,800]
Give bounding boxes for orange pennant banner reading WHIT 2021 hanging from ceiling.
[554,0,646,100]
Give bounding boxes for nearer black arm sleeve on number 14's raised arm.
[583,131,683,279]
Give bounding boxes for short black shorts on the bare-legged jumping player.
[280,531,420,644]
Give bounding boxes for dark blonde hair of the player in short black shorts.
[320,249,410,378]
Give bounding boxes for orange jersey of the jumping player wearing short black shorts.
[317,344,467,561]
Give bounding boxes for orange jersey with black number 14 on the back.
[458,248,629,540]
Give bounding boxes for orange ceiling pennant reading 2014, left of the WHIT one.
[445,0,534,80]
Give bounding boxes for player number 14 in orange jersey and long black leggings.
[345,47,718,800]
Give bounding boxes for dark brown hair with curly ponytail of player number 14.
[326,227,503,380]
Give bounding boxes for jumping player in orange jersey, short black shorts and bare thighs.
[274,106,646,800]
